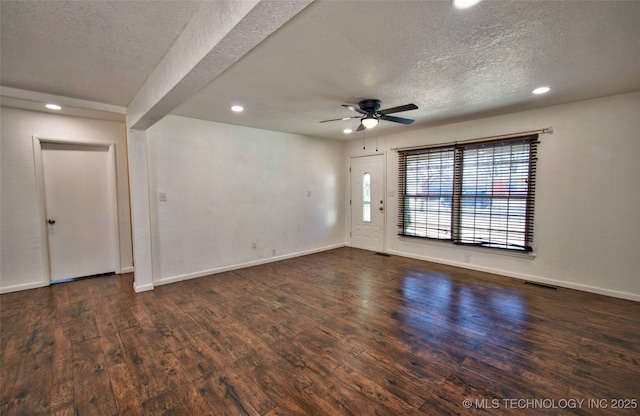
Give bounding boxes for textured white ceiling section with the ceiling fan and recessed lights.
[174,1,640,138]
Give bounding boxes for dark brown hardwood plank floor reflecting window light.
[0,248,640,416]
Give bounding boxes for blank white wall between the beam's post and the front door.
[147,116,345,284]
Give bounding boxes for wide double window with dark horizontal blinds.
[398,135,538,251]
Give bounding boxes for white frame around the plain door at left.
[32,136,122,286]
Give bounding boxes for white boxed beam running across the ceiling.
[127,0,313,130]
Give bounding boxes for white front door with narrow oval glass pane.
[351,155,385,252]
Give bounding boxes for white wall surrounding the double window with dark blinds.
[346,92,640,300]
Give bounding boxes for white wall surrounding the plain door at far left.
[0,107,132,293]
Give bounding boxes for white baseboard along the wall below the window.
[387,250,640,302]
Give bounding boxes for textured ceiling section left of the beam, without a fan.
[0,0,201,106]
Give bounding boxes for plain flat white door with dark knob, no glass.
[42,143,119,281]
